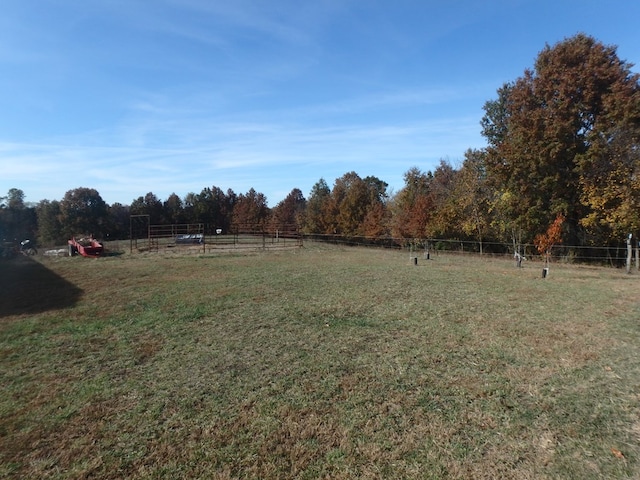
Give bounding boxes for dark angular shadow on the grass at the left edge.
[0,256,82,318]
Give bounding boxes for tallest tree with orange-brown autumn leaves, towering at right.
[482,34,640,248]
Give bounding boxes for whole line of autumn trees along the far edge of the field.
[0,34,640,249]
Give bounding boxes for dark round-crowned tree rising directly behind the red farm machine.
[60,188,108,238]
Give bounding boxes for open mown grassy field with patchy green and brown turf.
[0,245,640,480]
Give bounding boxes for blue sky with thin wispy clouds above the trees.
[0,0,640,206]
